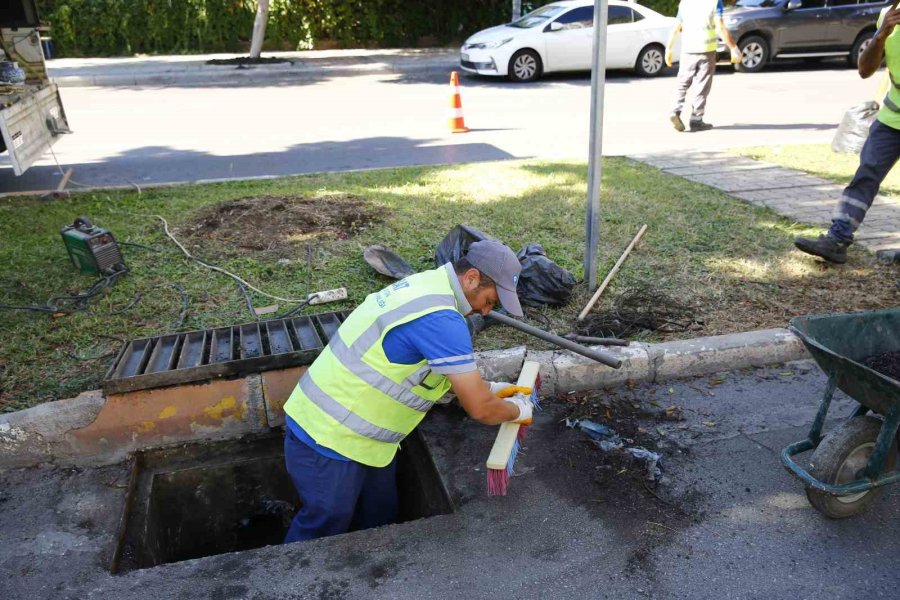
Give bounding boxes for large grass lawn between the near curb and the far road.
[0,159,897,411]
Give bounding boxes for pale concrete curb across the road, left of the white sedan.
[51,56,458,87]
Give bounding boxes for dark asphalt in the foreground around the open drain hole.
[0,362,900,600]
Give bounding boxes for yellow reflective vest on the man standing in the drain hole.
[284,265,459,467]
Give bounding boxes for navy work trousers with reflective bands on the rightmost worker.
[828,120,900,243]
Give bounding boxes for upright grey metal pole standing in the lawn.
[584,0,609,290]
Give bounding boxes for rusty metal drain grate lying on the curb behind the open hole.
[103,311,350,394]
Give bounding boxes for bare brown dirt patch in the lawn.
[182,194,383,256]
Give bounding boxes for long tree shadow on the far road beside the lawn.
[0,137,525,193]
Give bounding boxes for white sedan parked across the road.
[460,0,677,81]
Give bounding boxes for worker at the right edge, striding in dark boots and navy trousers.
[794,0,900,264]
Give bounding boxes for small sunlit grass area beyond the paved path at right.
[737,144,900,201]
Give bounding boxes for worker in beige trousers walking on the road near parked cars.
[666,0,741,131]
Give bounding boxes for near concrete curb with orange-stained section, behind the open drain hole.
[0,329,809,470]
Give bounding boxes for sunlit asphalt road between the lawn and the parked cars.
[0,61,877,193]
